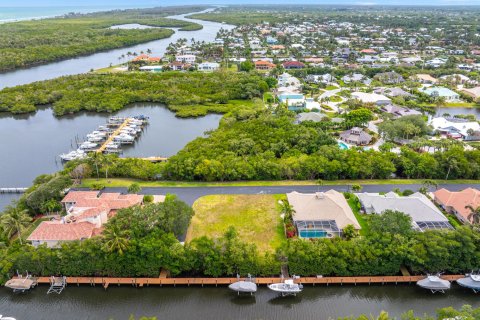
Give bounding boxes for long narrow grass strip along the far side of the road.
[78,178,480,188]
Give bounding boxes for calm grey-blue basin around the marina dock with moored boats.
[0,103,221,188]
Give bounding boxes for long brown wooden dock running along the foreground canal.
[25,275,464,289]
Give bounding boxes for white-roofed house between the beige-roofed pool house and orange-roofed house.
[356,192,453,231]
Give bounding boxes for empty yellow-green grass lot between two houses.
[186,195,285,252]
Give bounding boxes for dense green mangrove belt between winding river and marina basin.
[0,72,268,116]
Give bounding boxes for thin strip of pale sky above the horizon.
[0,0,480,6]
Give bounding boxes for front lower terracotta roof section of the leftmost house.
[27,221,95,241]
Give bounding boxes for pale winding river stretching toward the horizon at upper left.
[0,9,234,89]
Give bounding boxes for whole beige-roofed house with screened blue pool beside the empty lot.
[287,190,361,239]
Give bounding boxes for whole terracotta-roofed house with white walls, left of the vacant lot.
[27,191,143,248]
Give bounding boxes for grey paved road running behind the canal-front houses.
[79,183,480,205]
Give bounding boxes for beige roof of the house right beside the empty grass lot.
[287,190,361,230]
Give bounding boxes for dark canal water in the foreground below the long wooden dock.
[0,284,480,320]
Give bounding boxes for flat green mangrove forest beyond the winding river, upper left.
[0,7,202,71]
